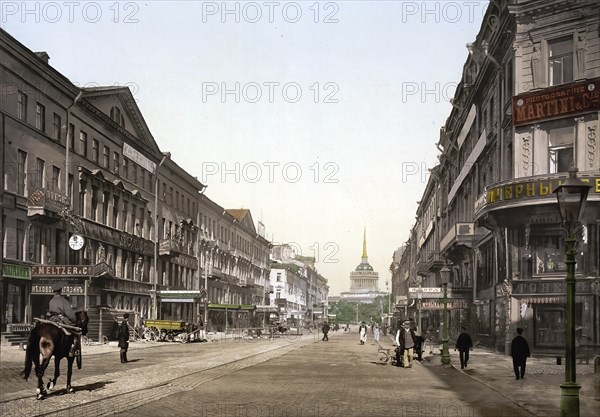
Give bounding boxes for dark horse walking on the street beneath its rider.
[21,311,88,400]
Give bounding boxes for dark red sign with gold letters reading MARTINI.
[512,78,600,126]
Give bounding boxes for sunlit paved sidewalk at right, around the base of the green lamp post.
[421,348,600,417]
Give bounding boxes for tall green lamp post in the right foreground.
[553,167,590,417]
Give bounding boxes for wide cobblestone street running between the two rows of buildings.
[0,332,600,417]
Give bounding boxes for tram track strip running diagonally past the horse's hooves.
[0,338,313,417]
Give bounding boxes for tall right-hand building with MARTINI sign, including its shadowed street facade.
[394,0,600,352]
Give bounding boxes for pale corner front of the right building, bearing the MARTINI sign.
[474,1,600,350]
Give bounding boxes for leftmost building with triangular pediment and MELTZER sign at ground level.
[0,30,161,337]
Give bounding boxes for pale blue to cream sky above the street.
[0,0,488,295]
